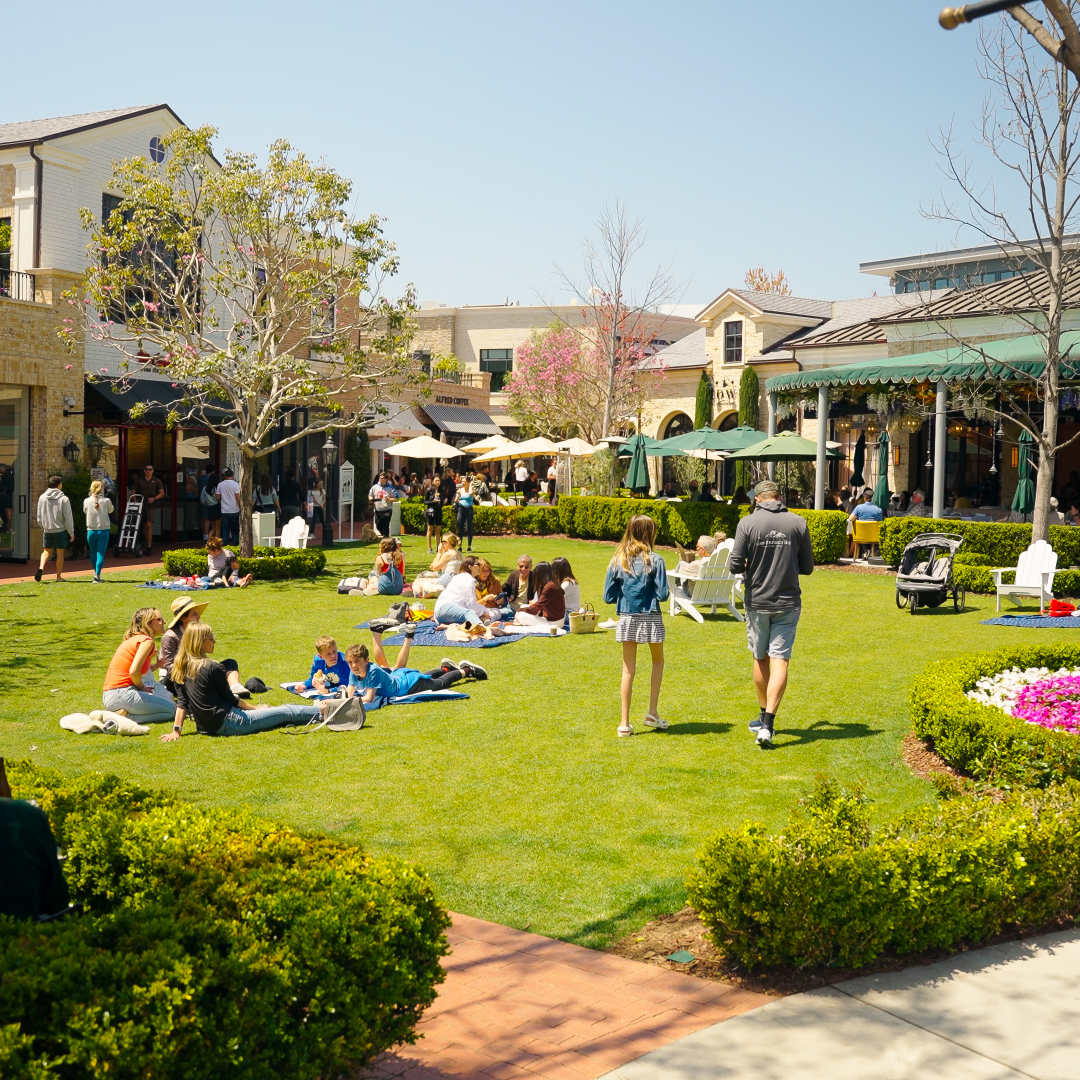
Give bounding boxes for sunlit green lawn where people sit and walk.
[0,537,1068,946]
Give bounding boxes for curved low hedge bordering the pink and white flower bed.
[910,645,1080,787]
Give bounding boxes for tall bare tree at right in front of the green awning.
[928,10,1080,539]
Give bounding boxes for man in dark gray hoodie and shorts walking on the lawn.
[728,481,813,750]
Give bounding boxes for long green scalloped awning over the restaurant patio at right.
[765,330,1080,394]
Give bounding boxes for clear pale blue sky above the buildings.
[6,0,985,305]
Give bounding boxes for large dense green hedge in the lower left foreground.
[0,762,449,1080]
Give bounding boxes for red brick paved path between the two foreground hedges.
[357,915,773,1080]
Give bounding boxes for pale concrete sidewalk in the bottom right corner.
[604,930,1080,1080]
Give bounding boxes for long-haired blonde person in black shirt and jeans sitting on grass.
[161,622,321,742]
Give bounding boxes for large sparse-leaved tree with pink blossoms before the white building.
[62,127,414,554]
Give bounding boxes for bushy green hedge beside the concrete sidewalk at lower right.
[687,781,1080,969]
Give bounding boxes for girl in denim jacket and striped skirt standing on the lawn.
[604,514,667,738]
